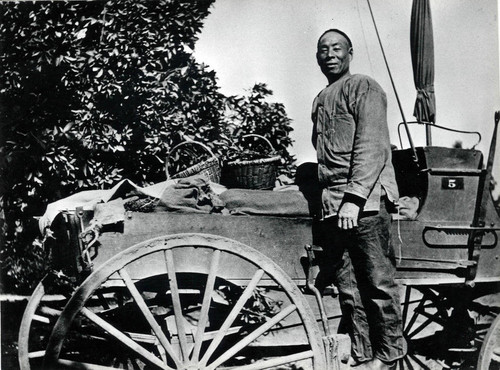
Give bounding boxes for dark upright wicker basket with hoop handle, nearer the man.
[222,134,281,189]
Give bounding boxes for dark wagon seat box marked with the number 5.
[392,146,500,280]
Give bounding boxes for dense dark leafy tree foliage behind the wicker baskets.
[0,0,293,294]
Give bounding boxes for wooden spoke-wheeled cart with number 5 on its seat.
[15,119,500,370]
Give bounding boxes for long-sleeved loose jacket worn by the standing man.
[312,74,399,217]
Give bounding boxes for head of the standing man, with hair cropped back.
[316,29,353,83]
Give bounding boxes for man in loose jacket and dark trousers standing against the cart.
[312,29,406,369]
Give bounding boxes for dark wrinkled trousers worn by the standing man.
[313,202,406,362]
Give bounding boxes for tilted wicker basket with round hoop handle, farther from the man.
[165,141,221,183]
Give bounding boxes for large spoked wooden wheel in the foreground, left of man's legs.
[45,234,326,370]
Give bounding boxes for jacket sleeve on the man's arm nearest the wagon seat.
[345,79,390,199]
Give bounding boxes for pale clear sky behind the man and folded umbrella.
[195,0,500,191]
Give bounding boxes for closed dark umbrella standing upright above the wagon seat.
[410,0,436,126]
